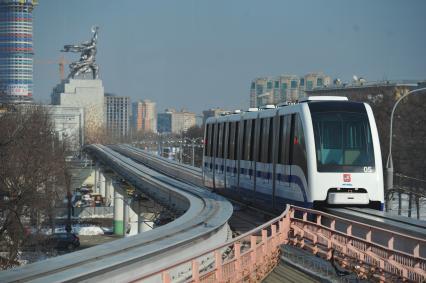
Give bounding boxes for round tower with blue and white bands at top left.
[0,0,38,102]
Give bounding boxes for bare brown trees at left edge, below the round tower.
[0,106,70,269]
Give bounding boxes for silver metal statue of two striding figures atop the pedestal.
[61,26,99,79]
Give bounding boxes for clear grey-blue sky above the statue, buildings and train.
[34,0,426,113]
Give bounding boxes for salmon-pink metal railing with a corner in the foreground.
[137,206,426,283]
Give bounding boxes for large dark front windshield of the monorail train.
[312,111,374,172]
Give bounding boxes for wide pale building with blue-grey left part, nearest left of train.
[158,109,196,134]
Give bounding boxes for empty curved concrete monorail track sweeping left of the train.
[0,145,232,282]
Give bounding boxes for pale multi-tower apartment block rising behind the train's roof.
[250,73,331,107]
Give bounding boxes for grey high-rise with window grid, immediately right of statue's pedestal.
[105,94,130,138]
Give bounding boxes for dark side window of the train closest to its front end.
[291,114,307,176]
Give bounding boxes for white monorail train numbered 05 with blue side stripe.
[203,96,384,211]
